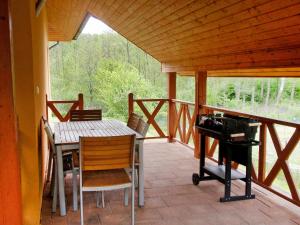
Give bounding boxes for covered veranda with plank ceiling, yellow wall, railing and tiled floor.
[0,0,300,225]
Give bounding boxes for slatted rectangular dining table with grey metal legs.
[54,120,144,216]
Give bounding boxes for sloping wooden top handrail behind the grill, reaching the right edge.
[201,105,300,128]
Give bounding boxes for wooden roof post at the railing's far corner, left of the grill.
[168,72,176,142]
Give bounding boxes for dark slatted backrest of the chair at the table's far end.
[70,109,102,121]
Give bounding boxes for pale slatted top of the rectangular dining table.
[54,120,144,145]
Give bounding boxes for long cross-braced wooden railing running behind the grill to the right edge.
[129,95,300,206]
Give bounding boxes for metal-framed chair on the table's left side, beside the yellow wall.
[43,118,79,212]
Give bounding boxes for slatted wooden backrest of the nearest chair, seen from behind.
[80,135,135,171]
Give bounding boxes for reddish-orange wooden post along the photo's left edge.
[0,0,22,225]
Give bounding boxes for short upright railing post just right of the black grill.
[258,123,267,183]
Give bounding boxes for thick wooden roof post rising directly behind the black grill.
[194,71,208,158]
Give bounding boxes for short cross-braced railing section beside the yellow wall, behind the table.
[46,94,83,122]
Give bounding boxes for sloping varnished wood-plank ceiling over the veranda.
[47,0,300,76]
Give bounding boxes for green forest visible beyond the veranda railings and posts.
[49,32,300,195]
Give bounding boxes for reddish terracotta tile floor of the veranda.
[42,141,300,225]
